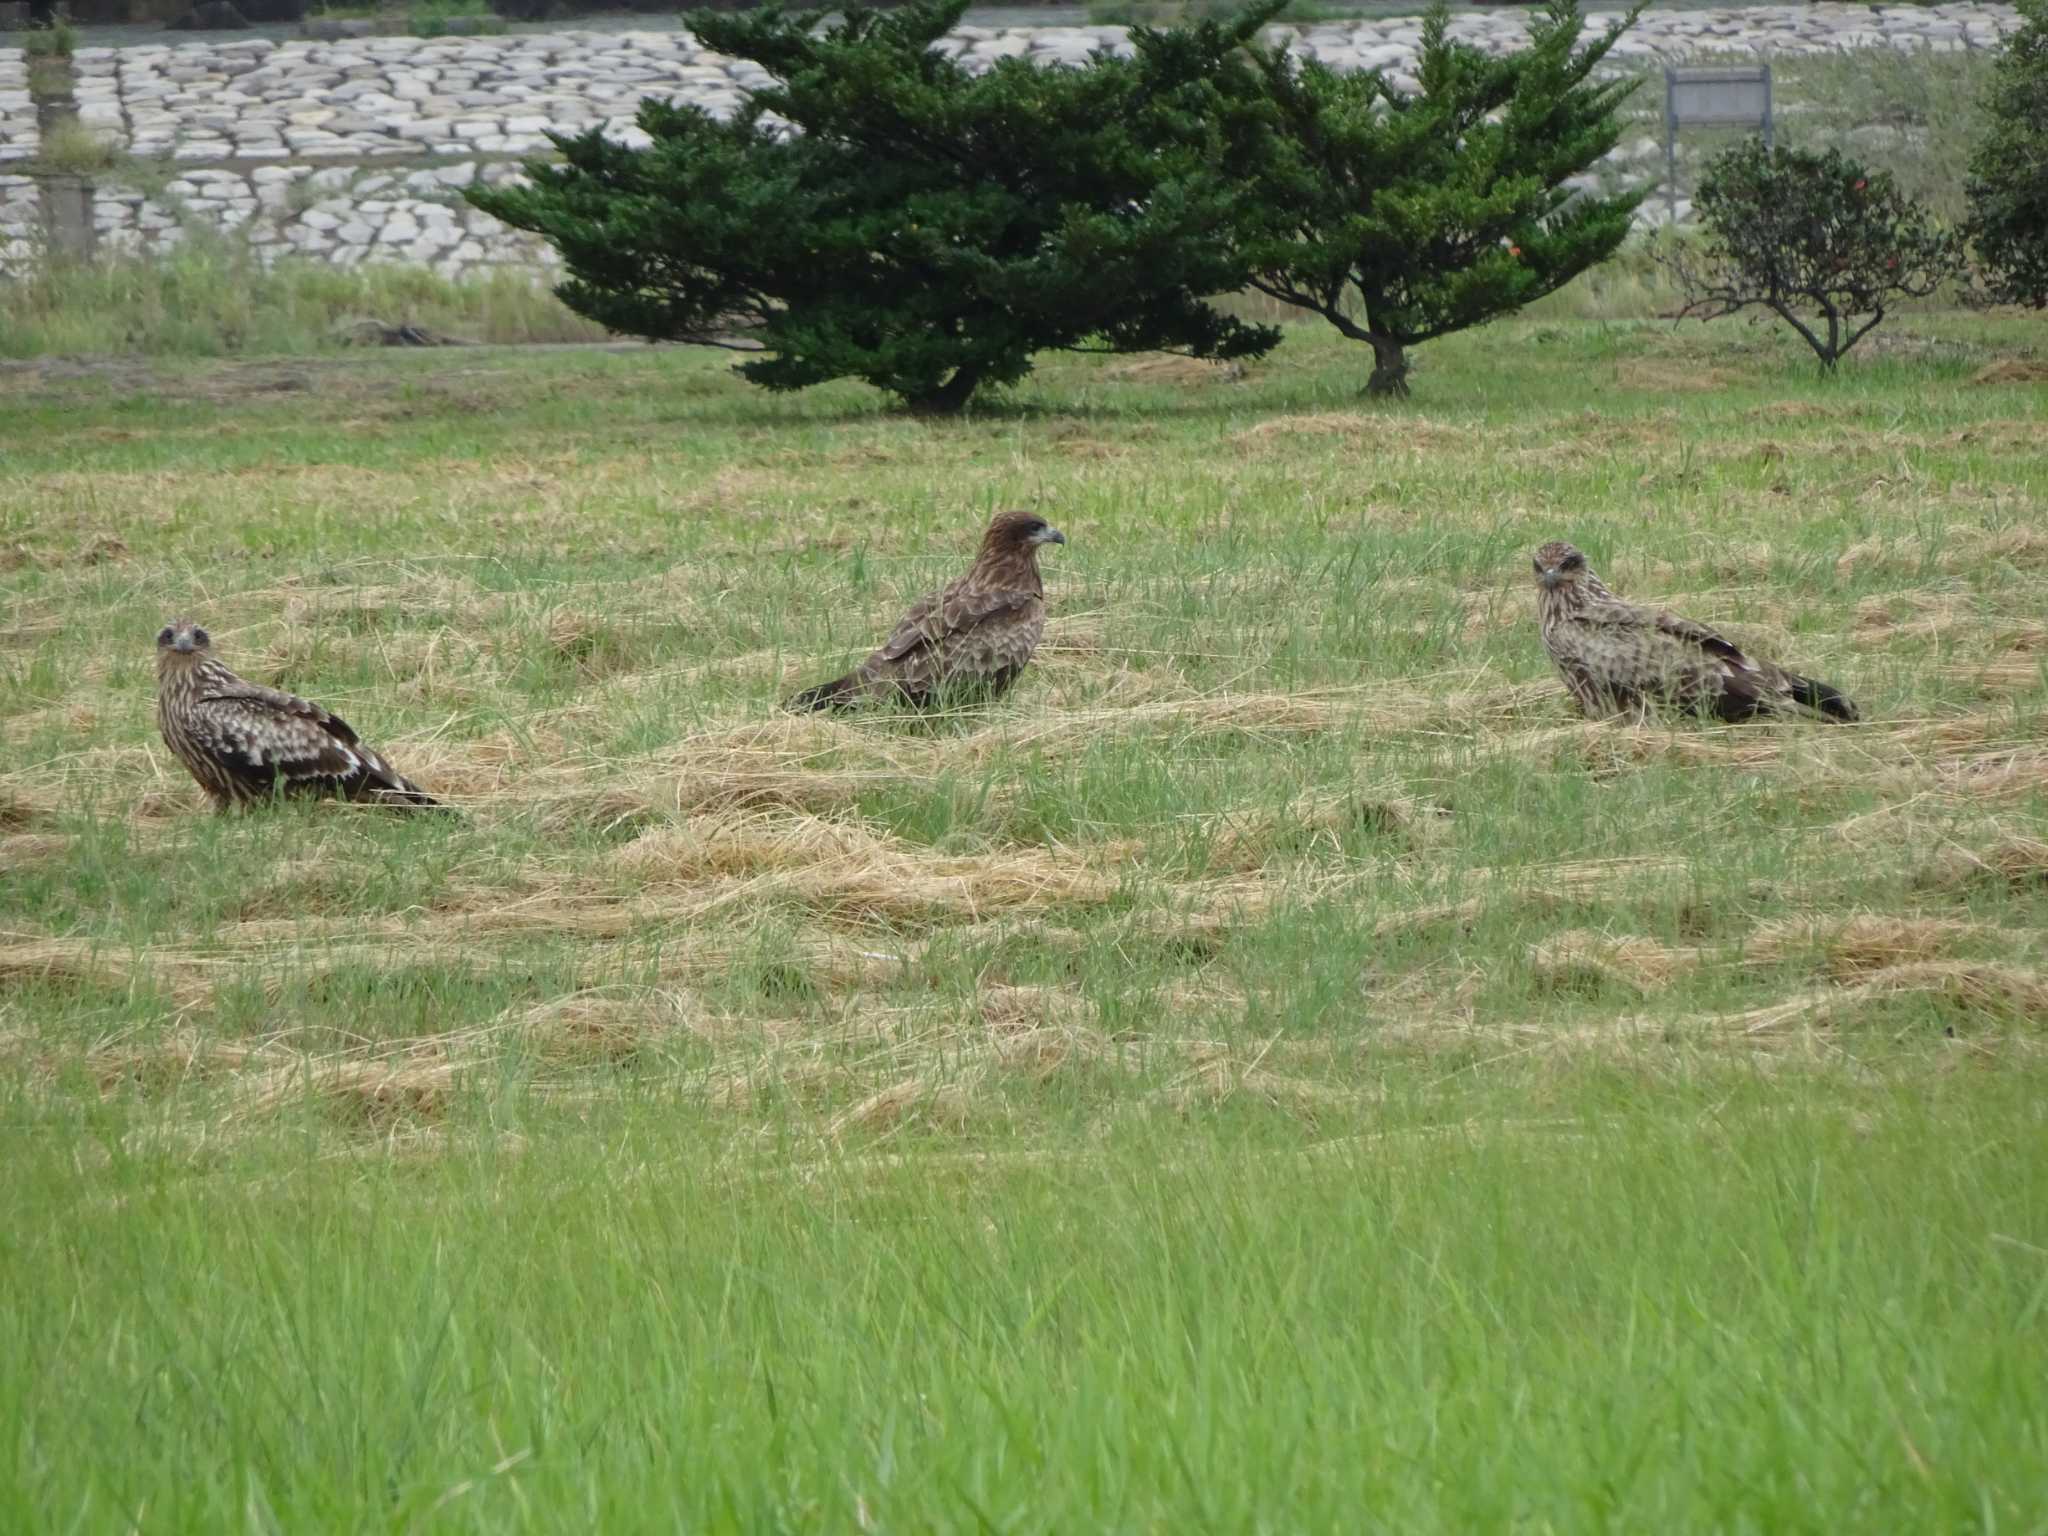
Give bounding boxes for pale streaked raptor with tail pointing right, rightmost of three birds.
[1536,543,1855,721]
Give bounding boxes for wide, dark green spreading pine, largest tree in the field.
[471,0,1278,412]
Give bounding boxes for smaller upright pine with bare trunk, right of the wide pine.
[1247,0,1642,395]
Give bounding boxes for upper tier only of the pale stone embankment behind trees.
[56,4,2013,164]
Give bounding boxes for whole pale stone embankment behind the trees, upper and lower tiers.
[0,4,2017,274]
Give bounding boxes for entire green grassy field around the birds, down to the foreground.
[0,313,2048,1534]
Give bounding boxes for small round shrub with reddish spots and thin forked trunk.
[1665,139,1964,369]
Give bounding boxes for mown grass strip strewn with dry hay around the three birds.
[0,319,2048,1137]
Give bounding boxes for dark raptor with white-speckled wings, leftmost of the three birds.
[156,618,440,811]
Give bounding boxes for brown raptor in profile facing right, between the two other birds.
[786,512,1067,711]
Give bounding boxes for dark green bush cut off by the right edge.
[1970,0,2048,309]
